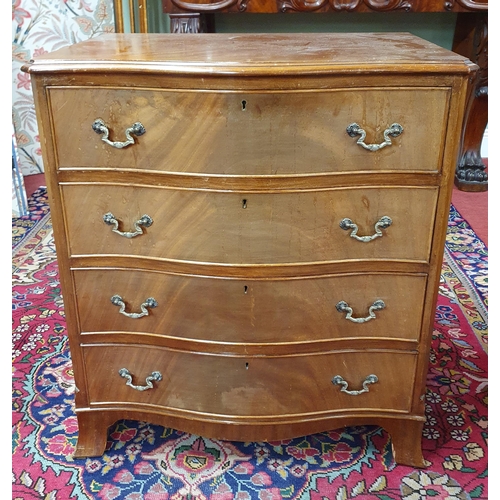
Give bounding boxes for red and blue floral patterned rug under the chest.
[12,189,488,500]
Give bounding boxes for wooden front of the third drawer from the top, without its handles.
[73,269,426,343]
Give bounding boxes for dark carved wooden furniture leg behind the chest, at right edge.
[453,14,488,191]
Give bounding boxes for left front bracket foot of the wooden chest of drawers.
[73,411,116,458]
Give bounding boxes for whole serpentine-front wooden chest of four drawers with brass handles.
[24,33,475,466]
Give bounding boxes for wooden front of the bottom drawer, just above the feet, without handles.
[83,345,416,417]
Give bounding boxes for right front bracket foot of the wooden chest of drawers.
[384,420,427,467]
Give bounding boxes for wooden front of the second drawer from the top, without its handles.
[62,185,437,264]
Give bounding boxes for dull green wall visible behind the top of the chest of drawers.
[148,8,457,49]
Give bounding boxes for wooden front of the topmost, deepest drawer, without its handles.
[50,88,449,175]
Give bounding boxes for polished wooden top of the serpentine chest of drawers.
[23,33,475,75]
